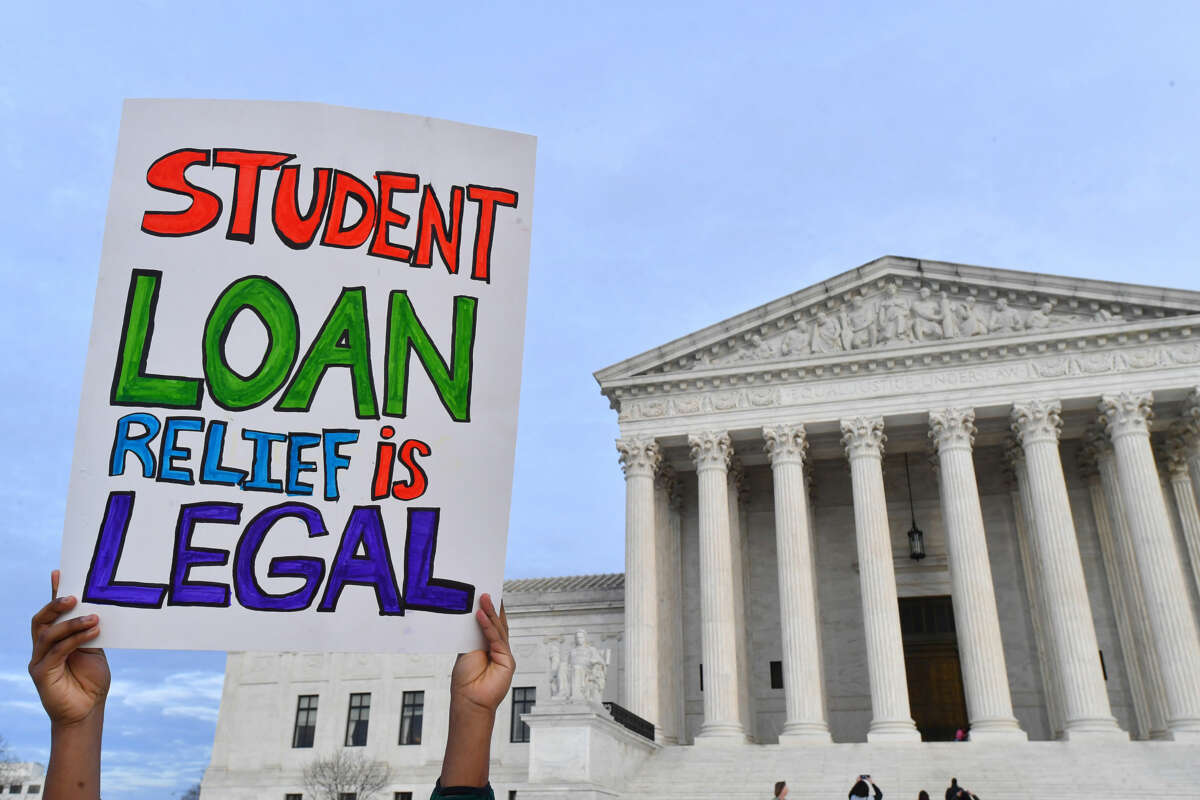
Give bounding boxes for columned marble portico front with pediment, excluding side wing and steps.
[596,257,1200,745]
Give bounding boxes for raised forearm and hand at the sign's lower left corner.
[29,570,109,800]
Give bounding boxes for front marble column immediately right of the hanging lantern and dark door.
[929,408,1026,741]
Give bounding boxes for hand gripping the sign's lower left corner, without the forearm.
[29,570,112,726]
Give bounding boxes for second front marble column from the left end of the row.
[688,431,746,745]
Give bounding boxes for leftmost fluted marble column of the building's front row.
[617,437,662,726]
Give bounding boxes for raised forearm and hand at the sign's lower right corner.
[431,595,517,800]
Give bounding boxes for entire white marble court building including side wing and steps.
[203,257,1200,800]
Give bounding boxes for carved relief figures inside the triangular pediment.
[656,279,1140,372]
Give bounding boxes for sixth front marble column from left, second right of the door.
[1012,401,1128,740]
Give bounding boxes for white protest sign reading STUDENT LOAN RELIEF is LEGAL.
[61,101,535,651]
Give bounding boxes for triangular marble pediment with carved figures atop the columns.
[595,255,1200,386]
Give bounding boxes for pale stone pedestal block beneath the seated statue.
[521,702,661,800]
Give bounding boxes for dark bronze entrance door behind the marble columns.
[900,596,967,741]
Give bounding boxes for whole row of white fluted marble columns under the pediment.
[618,390,1200,744]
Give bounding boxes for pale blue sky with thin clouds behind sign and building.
[0,1,1200,800]
